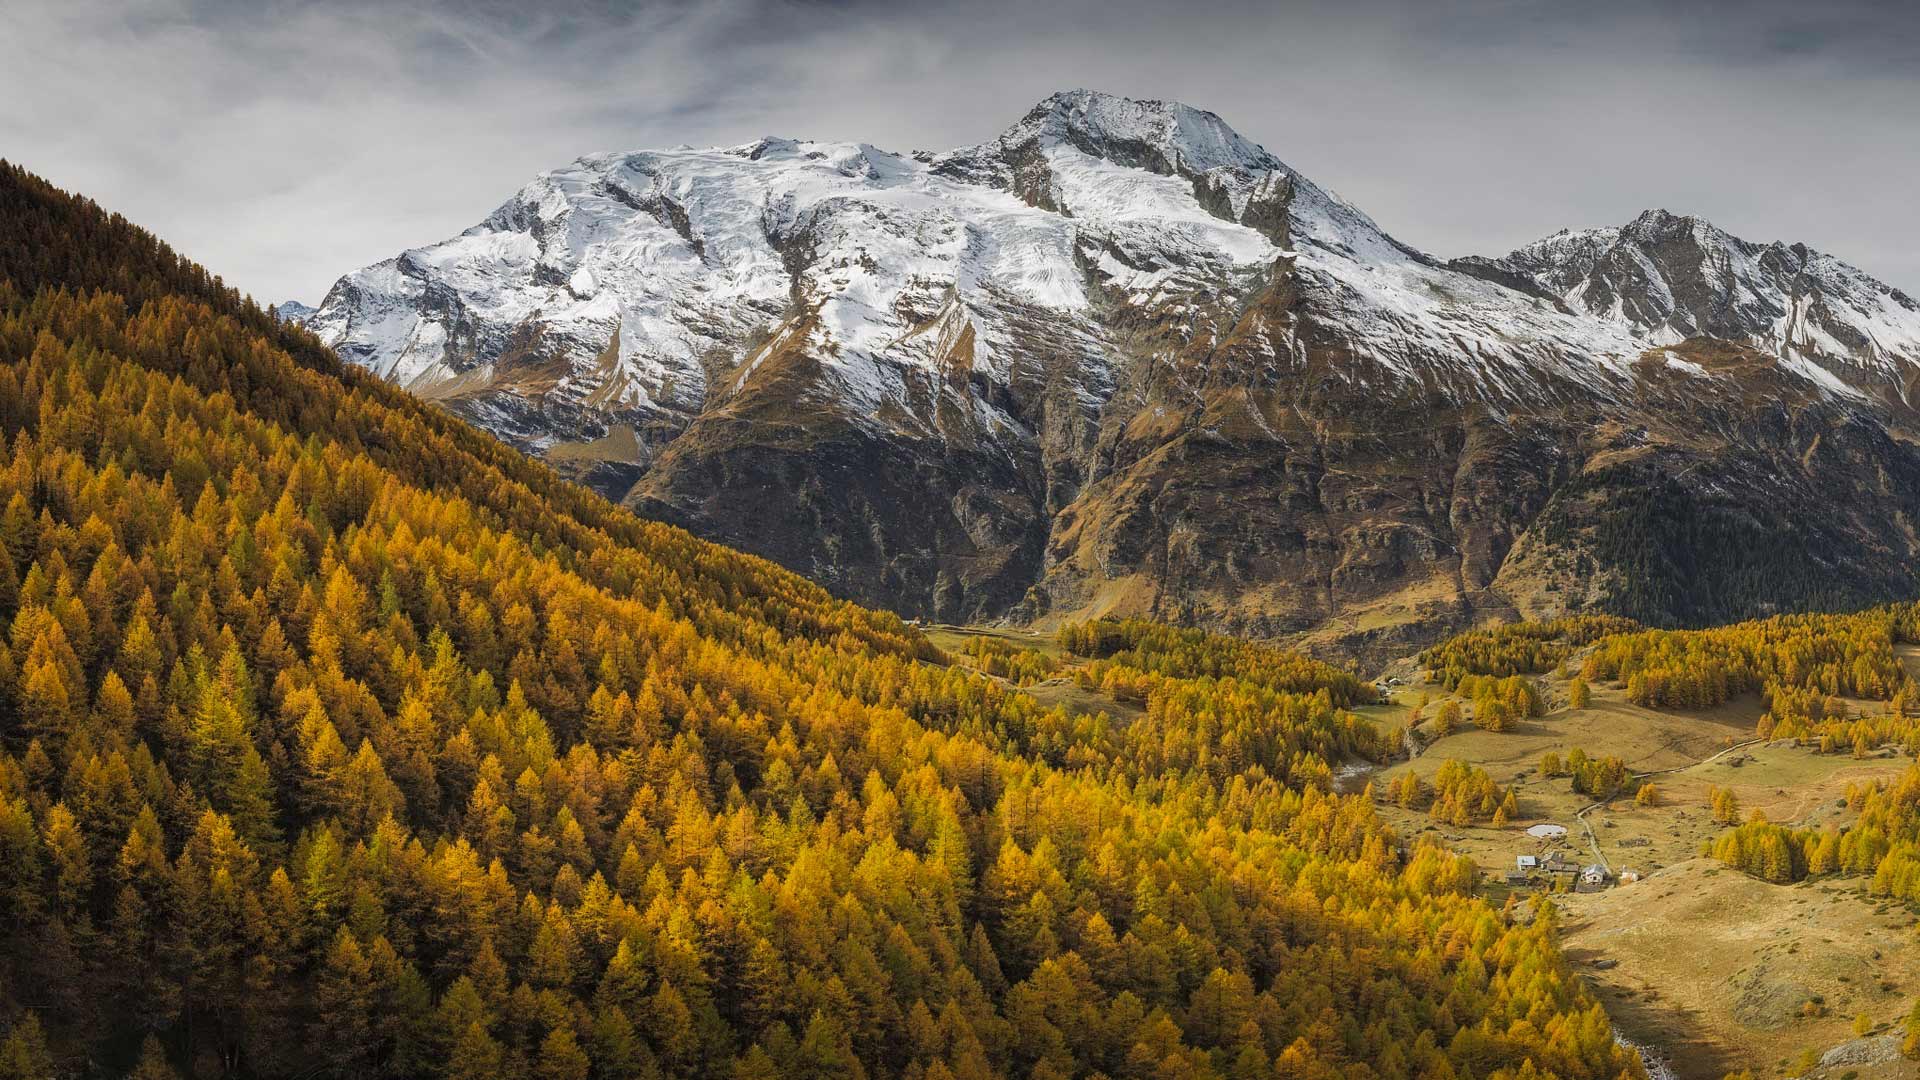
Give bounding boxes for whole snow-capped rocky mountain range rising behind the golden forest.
[305,90,1920,655]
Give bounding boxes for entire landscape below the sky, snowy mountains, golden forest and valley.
[0,79,1920,1080]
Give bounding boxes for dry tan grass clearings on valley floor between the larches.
[927,626,1920,1080]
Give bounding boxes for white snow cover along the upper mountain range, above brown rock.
[311,90,1920,449]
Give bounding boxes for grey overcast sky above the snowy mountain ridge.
[0,0,1920,304]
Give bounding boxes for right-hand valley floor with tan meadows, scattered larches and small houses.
[1397,603,1920,1080]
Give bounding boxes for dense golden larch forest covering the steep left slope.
[0,167,1640,1080]
